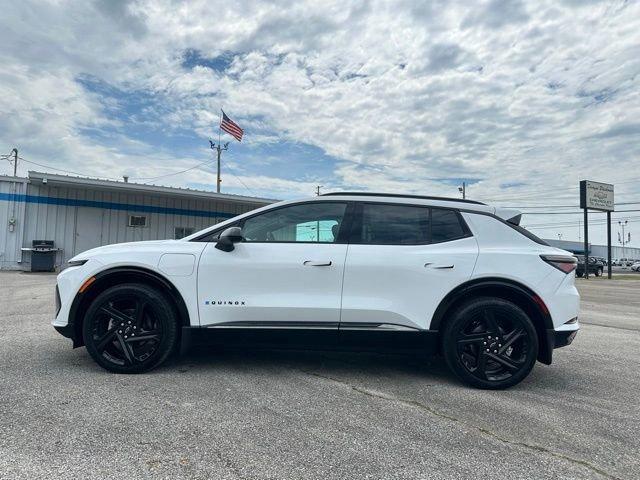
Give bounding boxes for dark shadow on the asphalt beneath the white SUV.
[56,347,581,392]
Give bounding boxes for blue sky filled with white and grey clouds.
[0,0,640,245]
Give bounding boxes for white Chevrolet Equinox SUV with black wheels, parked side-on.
[53,193,579,388]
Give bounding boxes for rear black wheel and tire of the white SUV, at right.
[442,297,538,390]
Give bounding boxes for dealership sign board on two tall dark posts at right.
[580,180,615,278]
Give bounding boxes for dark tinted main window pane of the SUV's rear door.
[360,204,429,245]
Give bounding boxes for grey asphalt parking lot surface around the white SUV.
[0,272,640,479]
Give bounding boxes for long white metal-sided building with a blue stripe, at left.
[0,171,274,270]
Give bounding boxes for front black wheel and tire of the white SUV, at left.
[82,283,178,373]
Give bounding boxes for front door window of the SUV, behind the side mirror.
[242,202,347,243]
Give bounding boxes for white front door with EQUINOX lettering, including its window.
[198,201,347,329]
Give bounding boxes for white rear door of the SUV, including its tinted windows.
[340,203,478,331]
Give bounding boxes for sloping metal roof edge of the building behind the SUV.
[22,170,278,204]
